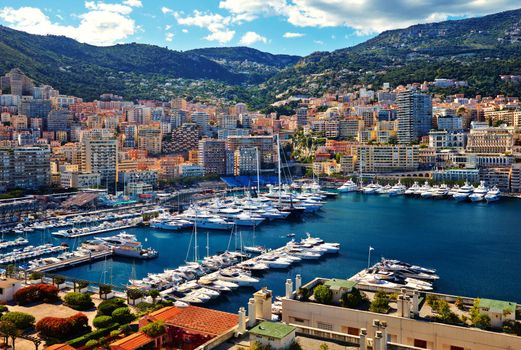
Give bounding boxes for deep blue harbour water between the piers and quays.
[8,193,521,312]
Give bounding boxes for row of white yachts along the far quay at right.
[338,180,501,202]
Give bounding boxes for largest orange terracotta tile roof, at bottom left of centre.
[149,306,239,336]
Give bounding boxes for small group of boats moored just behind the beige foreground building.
[350,258,439,291]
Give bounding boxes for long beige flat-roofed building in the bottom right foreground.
[282,279,521,350]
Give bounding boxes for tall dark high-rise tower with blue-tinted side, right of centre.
[397,90,432,144]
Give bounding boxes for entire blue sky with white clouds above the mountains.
[0,0,521,55]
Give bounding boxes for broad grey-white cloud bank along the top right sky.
[213,0,519,35]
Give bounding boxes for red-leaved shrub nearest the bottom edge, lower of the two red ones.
[36,313,90,340]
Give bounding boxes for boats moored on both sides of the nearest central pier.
[129,235,340,304]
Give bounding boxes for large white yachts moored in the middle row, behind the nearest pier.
[150,186,332,231]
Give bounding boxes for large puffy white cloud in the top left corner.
[0,2,137,46]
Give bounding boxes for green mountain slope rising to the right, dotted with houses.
[260,10,521,101]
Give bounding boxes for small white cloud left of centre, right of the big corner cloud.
[174,10,235,44]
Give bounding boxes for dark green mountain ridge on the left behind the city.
[0,26,284,99]
